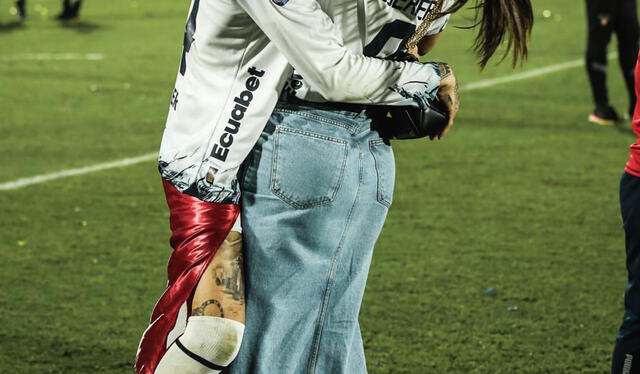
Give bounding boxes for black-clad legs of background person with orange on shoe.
[586,0,640,125]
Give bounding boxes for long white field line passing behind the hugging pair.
[0,54,616,191]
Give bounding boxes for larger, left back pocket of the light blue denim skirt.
[271,126,348,209]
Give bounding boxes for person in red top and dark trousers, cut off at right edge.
[611,51,640,374]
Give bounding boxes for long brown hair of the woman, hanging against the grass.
[447,0,533,67]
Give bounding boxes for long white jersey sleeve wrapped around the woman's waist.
[237,0,440,107]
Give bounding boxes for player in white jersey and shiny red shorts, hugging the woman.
[136,0,464,374]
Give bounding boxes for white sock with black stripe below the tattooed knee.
[155,316,244,374]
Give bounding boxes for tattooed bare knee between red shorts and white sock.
[191,231,245,323]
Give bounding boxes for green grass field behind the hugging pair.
[0,0,633,374]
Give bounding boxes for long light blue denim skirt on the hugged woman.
[229,104,395,374]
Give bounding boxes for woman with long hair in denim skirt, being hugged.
[229,0,533,374]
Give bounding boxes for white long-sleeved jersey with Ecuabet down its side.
[159,0,451,203]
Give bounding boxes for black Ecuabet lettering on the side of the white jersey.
[211,67,264,161]
